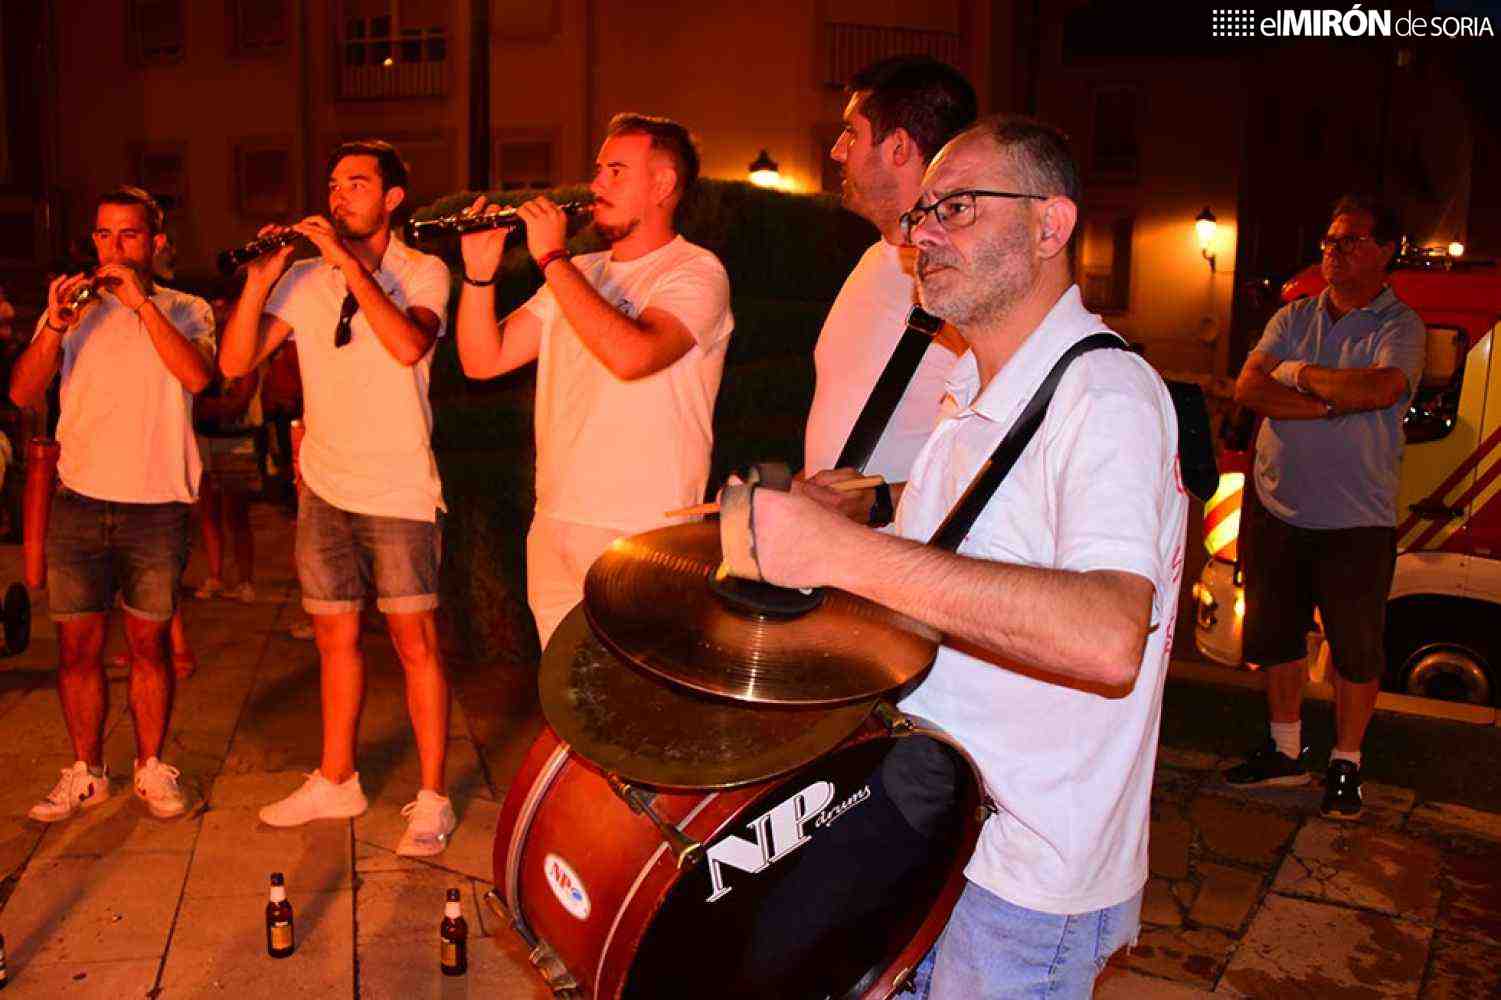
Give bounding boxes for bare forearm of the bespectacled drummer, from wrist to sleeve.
[824,513,1151,688]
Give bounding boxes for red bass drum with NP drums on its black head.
[494,706,989,1000]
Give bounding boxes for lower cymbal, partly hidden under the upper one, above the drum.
[537,607,875,790]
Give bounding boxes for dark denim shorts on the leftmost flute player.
[47,486,191,622]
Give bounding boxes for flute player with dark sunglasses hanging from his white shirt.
[219,140,456,856]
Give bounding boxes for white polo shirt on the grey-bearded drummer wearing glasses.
[896,287,1187,914]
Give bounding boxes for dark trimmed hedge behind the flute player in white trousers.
[416,180,877,662]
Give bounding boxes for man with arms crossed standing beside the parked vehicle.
[1225,197,1426,820]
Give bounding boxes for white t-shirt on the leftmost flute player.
[47,287,213,503]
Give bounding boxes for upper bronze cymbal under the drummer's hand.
[584,521,938,706]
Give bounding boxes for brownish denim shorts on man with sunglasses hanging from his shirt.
[297,486,443,614]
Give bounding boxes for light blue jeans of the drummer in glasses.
[913,881,1142,1000]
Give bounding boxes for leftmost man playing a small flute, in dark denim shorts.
[11,188,213,823]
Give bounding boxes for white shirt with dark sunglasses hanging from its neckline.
[266,236,449,521]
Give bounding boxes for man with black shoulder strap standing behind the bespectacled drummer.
[803,56,976,526]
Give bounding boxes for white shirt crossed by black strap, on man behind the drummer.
[803,240,956,482]
